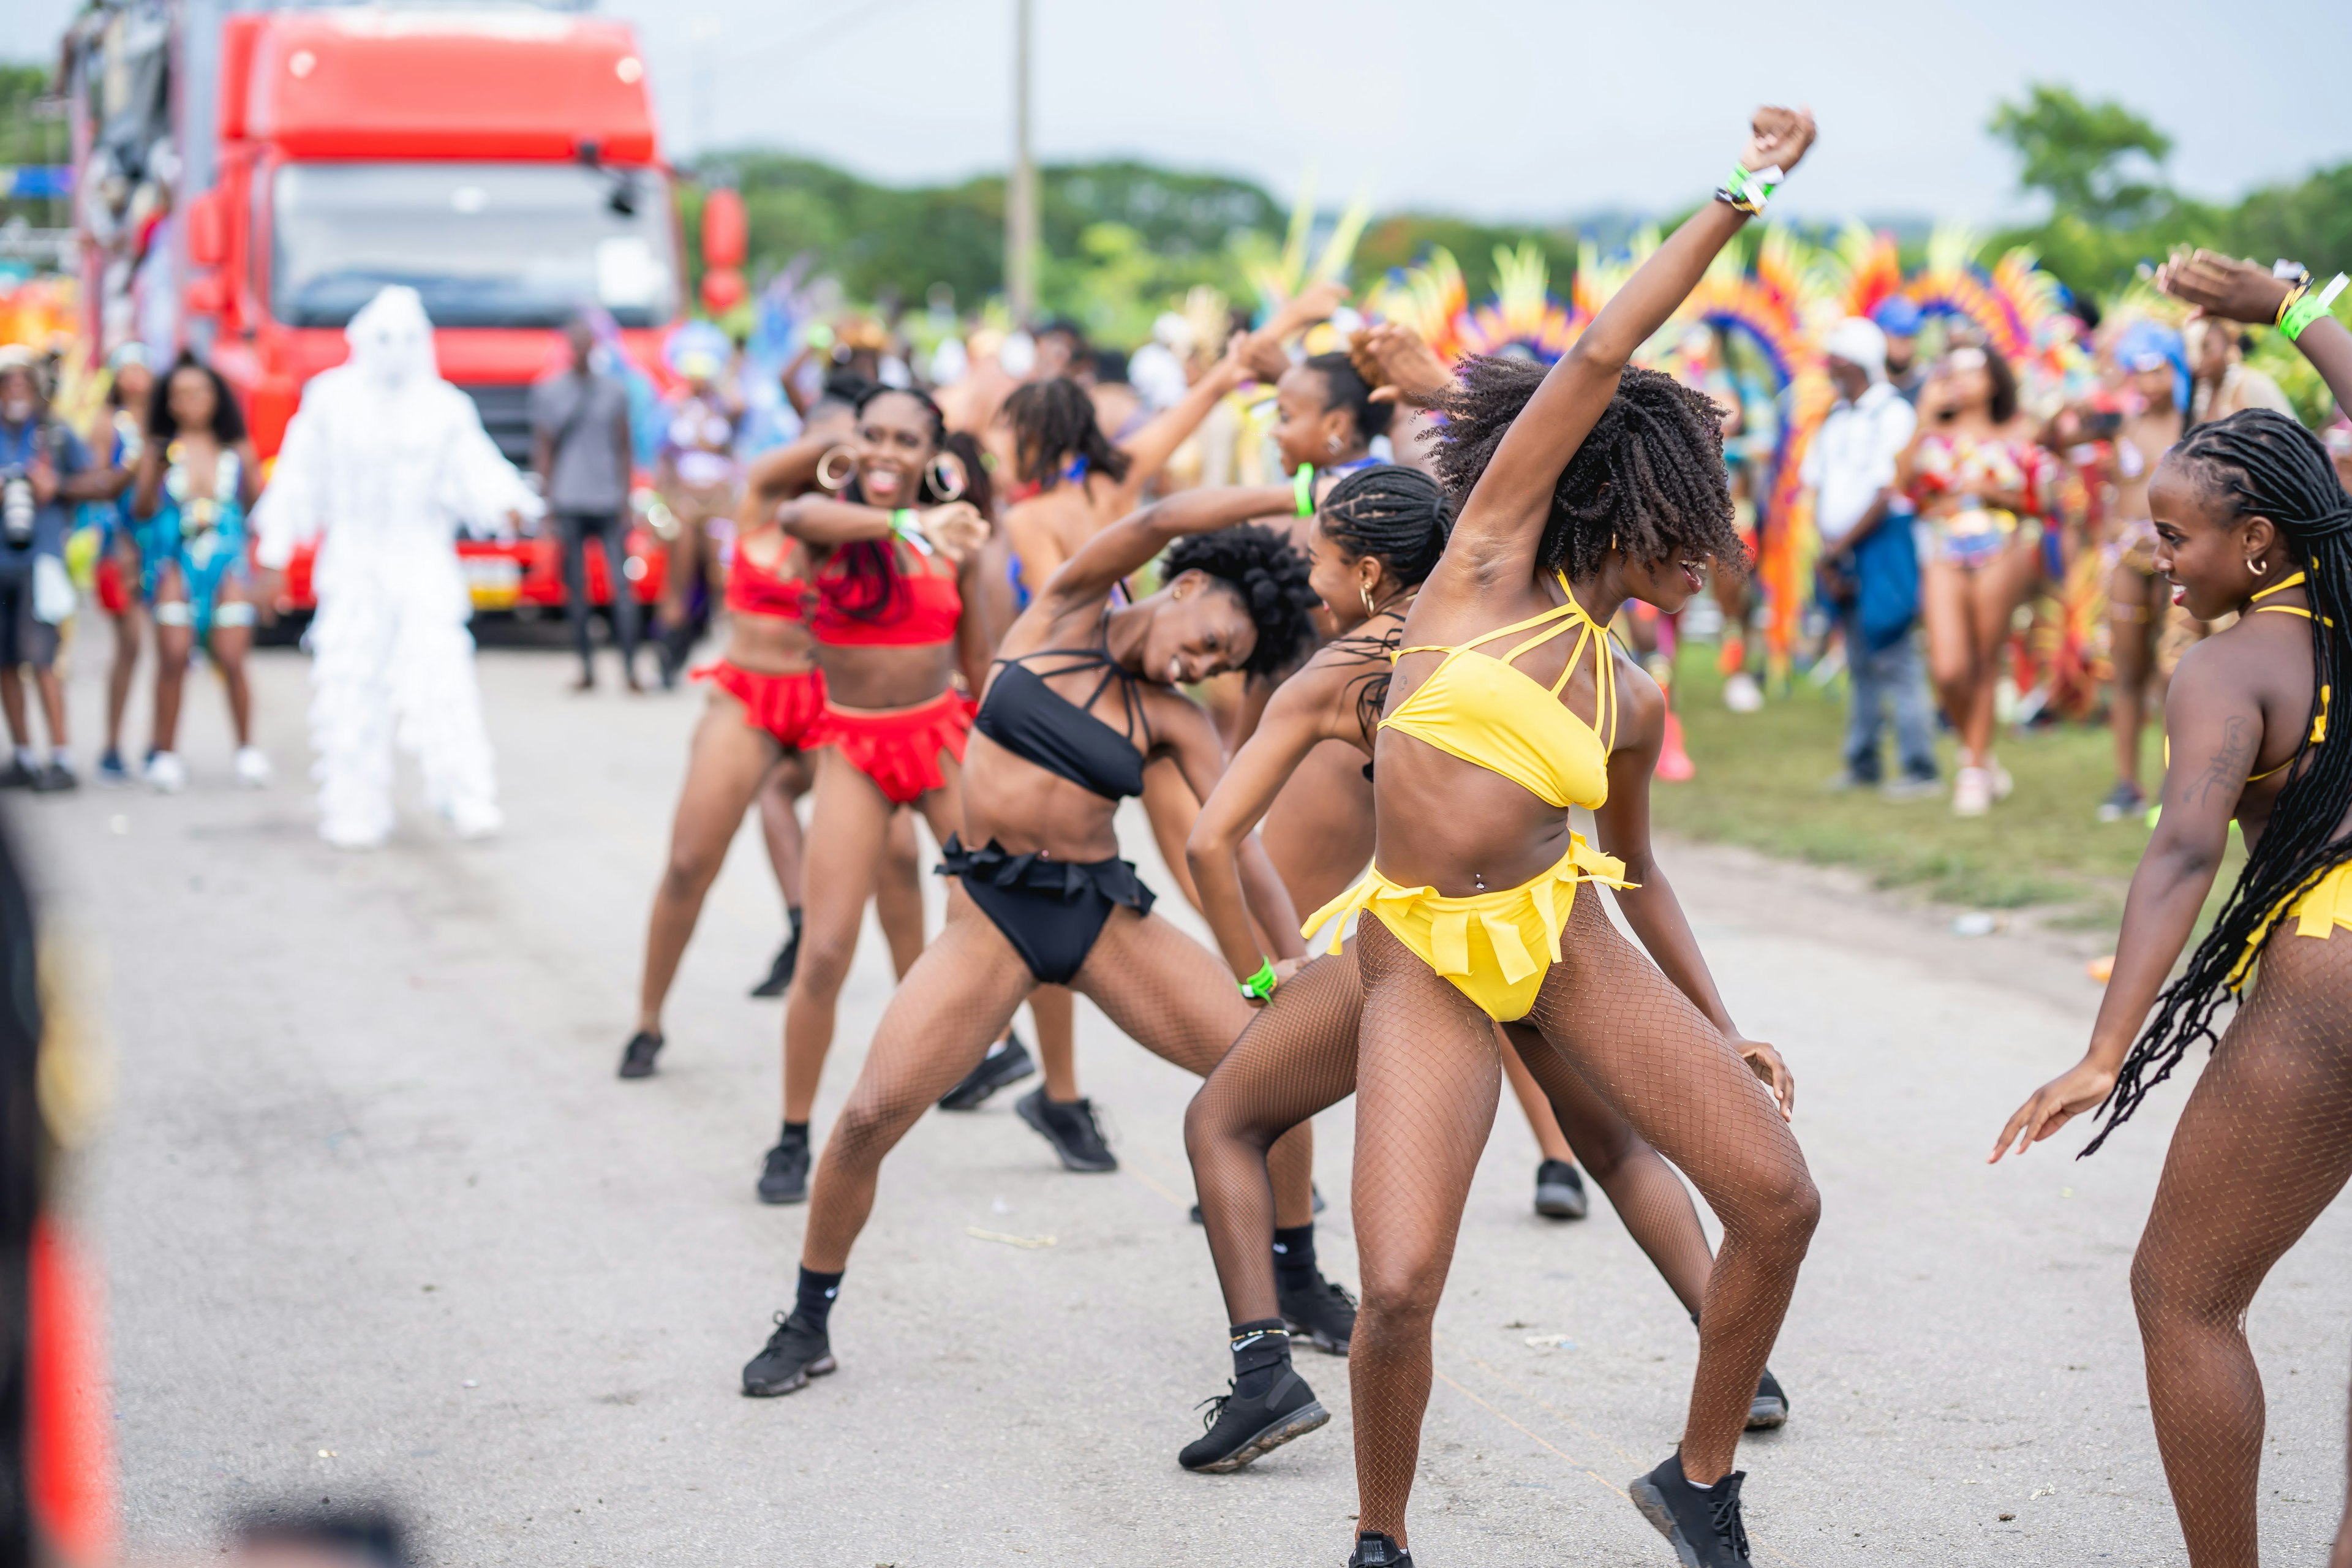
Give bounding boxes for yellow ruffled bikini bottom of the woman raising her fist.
[1298,832,1632,1023]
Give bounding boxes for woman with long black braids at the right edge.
[1992,252,2352,1568]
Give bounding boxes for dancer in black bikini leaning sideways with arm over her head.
[743,486,1315,1396]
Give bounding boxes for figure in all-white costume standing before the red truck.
[254,287,538,849]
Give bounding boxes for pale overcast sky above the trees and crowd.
[12,0,2352,224]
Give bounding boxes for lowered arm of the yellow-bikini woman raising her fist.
[1593,670,1797,1119]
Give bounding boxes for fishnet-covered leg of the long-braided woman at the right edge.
[2131,931,2352,1568]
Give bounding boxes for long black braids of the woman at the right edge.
[2084,409,2352,1154]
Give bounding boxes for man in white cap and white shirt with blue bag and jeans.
[1801,317,1938,799]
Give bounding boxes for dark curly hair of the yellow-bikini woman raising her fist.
[1437,355,1750,576]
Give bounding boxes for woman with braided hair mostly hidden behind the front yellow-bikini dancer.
[1178,466,1787,1472]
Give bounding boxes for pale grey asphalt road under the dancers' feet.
[23,632,2352,1568]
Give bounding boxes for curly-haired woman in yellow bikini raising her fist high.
[1310,108,1818,1568]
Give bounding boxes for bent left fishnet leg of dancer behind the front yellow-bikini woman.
[1183,948,1364,1324]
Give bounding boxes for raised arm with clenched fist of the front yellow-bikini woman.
[1439,108,1814,583]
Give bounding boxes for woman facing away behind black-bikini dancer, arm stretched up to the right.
[938,343,1246,1152]
